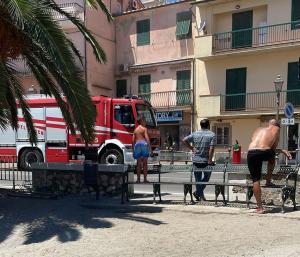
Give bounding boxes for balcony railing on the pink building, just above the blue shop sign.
[139,89,193,108]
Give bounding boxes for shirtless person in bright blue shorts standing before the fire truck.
[132,116,152,183]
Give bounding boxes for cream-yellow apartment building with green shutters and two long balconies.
[193,0,300,160]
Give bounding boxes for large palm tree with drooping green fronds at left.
[0,0,112,143]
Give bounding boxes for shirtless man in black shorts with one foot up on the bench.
[247,119,292,214]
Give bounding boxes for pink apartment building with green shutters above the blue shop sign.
[115,1,195,150]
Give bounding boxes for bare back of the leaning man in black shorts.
[249,126,280,150]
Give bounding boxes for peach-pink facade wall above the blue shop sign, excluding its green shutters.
[115,1,196,149]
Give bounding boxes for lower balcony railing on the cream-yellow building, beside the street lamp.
[221,89,300,112]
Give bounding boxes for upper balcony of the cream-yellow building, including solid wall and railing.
[196,21,300,59]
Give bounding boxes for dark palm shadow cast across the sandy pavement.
[0,194,162,244]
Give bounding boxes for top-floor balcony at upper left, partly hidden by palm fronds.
[52,3,84,29]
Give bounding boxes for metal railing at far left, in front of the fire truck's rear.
[0,155,32,191]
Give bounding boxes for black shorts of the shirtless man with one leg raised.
[247,149,275,182]
